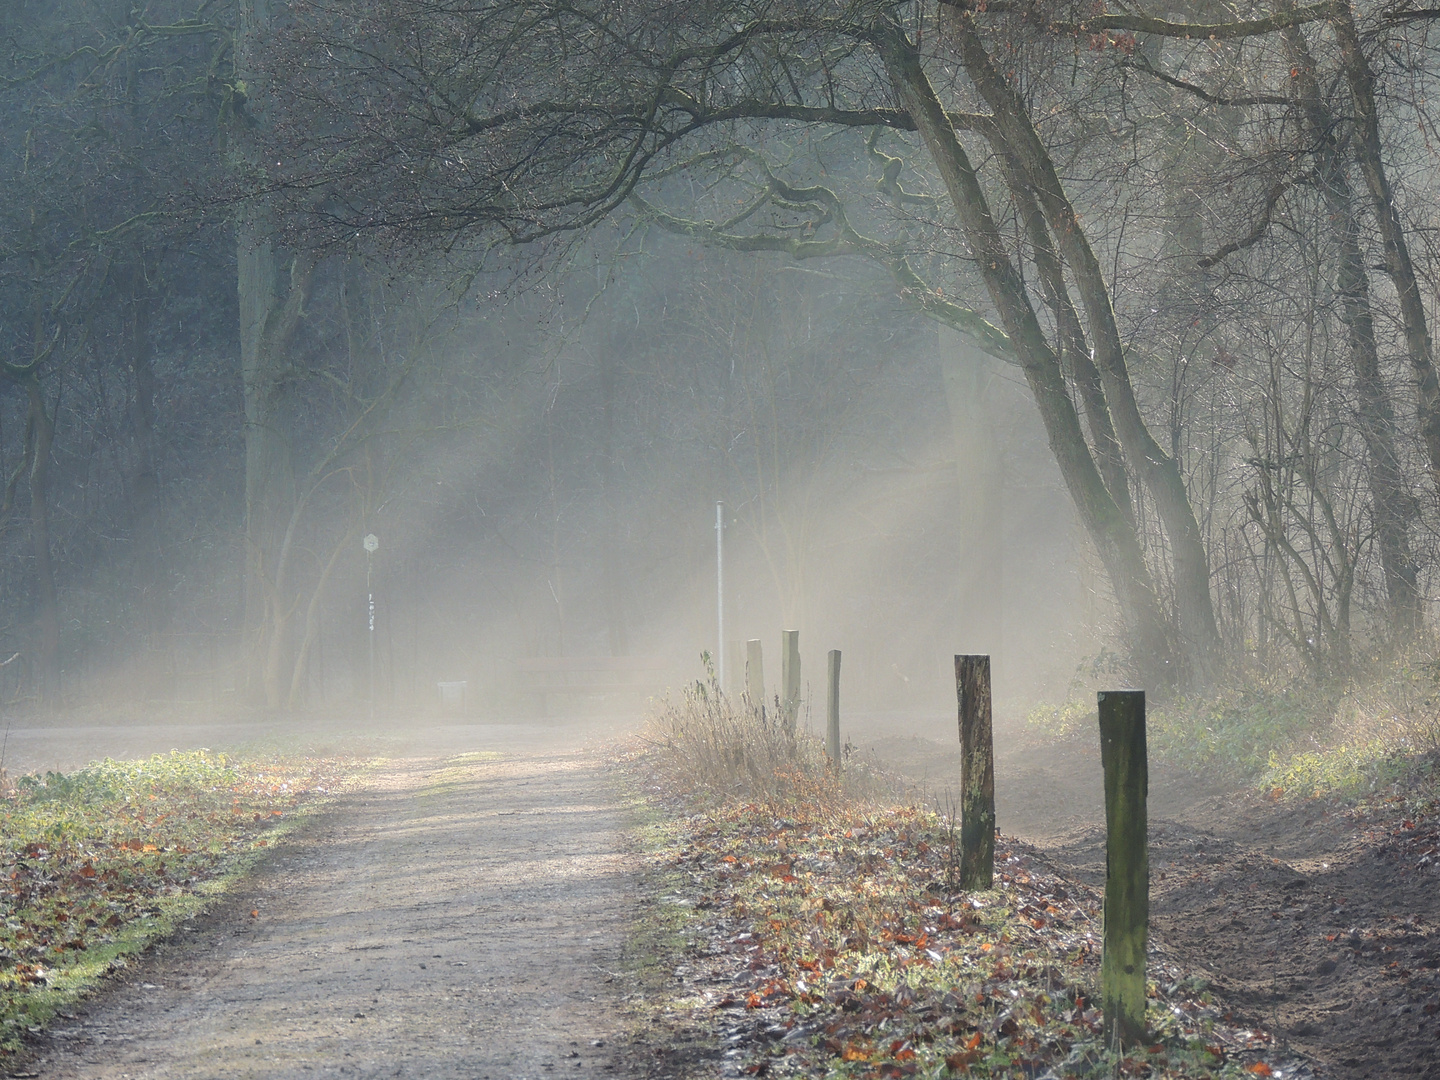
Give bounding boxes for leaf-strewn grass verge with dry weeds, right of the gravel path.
[626,687,1284,1080]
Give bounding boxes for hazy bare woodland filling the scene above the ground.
[0,0,1440,766]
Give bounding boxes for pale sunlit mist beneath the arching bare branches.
[0,239,1106,748]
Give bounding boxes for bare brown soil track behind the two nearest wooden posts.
[870,736,1440,1080]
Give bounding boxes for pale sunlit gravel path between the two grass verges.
[21,750,635,1080]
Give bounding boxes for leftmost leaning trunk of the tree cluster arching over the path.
[876,24,1174,685]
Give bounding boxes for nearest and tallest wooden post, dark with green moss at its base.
[1097,690,1151,1050]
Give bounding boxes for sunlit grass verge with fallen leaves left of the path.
[0,750,366,1060]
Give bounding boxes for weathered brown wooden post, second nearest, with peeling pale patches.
[955,655,995,891]
